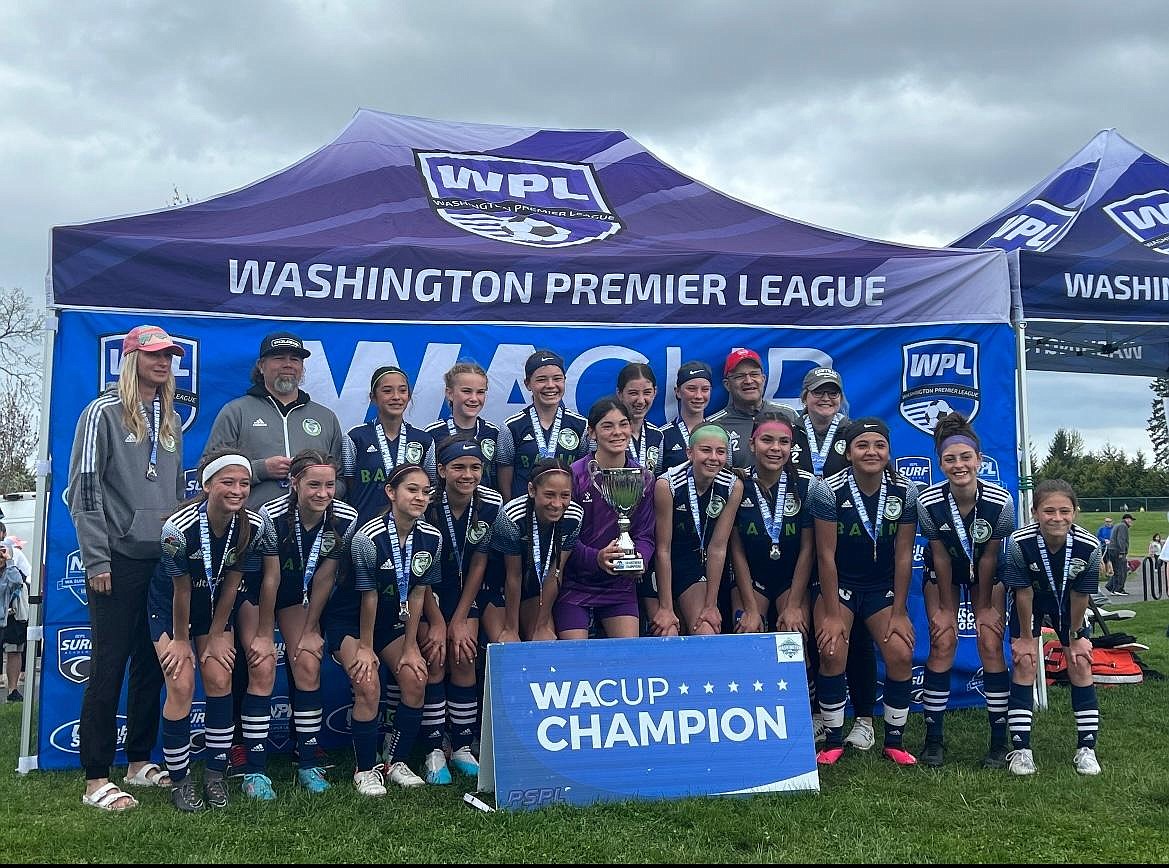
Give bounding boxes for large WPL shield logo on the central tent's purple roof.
[414,151,621,248]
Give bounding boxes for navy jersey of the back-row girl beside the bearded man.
[341,422,437,525]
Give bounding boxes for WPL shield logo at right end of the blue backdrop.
[898,339,980,435]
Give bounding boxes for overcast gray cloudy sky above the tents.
[0,0,1169,456]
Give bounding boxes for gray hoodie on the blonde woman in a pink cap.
[68,388,186,578]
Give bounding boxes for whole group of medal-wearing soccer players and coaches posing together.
[65,325,1101,812]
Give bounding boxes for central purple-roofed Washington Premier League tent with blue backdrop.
[25,111,1018,768]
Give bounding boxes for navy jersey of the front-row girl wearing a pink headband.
[735,471,814,588]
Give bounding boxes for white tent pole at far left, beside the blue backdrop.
[16,306,58,775]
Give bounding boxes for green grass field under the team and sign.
[0,602,1169,864]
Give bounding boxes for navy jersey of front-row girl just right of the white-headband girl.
[259,497,358,609]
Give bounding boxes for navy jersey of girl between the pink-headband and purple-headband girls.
[811,467,918,590]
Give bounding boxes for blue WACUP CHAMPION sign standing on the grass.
[479,633,819,810]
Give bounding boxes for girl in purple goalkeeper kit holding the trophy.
[553,399,656,639]
